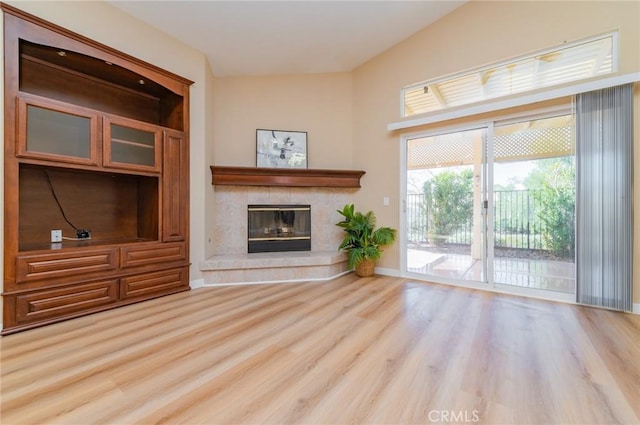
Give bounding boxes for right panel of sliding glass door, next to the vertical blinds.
[492,115,576,294]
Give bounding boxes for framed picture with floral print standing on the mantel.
[256,129,307,168]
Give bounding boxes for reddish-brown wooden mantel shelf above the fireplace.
[211,165,365,188]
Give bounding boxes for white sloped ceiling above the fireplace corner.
[110,0,466,76]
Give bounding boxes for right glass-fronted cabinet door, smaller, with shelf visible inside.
[104,118,162,171]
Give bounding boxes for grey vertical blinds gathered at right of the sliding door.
[576,84,633,311]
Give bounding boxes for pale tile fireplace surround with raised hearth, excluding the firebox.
[200,186,357,285]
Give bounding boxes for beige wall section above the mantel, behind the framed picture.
[213,73,353,169]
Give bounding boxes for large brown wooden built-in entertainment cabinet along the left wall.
[1,4,192,334]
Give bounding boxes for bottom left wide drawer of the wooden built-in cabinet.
[16,279,118,324]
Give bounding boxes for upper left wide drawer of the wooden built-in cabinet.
[16,248,118,282]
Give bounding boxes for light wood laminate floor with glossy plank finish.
[0,274,640,425]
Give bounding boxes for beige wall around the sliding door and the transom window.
[353,1,640,303]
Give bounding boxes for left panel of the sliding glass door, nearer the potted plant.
[405,128,487,282]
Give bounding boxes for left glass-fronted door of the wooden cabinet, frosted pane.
[18,98,97,165]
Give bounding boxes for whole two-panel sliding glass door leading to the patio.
[404,115,575,294]
